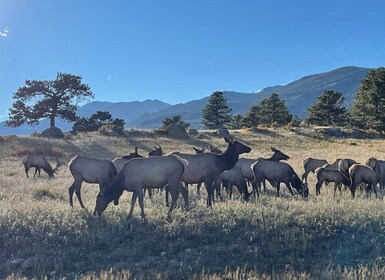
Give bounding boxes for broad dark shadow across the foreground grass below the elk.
[0,200,385,279]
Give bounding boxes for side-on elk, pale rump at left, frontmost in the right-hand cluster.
[314,167,351,197]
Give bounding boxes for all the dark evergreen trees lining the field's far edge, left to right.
[6,67,385,134]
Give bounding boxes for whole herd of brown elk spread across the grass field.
[22,137,385,218]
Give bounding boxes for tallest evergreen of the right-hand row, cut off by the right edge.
[350,67,385,131]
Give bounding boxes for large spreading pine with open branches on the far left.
[6,73,94,128]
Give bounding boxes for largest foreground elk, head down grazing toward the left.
[94,155,188,219]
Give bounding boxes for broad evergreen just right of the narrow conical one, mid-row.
[259,93,292,125]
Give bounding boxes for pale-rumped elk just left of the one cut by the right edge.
[349,163,378,197]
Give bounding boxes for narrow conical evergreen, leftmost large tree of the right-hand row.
[202,91,231,129]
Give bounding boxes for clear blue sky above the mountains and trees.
[0,0,385,121]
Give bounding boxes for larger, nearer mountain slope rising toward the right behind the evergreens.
[127,66,370,128]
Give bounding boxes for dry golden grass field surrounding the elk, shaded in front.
[0,129,385,279]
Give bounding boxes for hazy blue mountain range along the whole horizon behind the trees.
[0,66,370,135]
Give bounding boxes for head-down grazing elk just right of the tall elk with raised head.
[251,159,309,197]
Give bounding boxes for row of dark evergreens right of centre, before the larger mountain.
[202,67,385,131]
